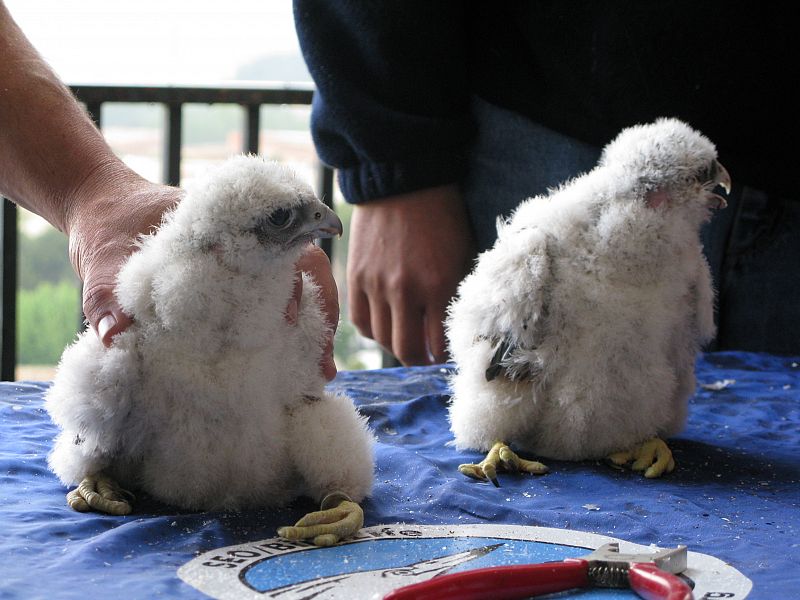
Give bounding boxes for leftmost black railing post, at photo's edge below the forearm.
[0,198,17,381]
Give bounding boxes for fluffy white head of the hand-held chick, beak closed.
[173,156,342,265]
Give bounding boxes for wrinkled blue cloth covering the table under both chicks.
[0,353,800,599]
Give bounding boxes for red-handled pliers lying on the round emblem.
[383,542,693,600]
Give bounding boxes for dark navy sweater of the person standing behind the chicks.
[295,0,798,202]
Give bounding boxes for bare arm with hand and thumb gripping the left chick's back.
[0,0,180,345]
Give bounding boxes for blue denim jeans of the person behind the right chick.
[463,99,800,355]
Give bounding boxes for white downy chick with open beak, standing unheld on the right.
[446,119,730,484]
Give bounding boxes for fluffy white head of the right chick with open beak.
[599,118,731,214]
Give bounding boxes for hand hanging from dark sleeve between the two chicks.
[347,185,475,365]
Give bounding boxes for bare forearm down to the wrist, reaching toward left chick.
[0,0,140,233]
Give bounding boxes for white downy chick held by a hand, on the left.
[46,156,373,544]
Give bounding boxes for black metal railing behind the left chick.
[0,83,333,381]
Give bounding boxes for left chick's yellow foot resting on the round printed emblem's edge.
[278,492,364,546]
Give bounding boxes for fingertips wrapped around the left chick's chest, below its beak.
[286,244,339,381]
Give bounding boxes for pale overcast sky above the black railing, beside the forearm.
[5,0,300,84]
